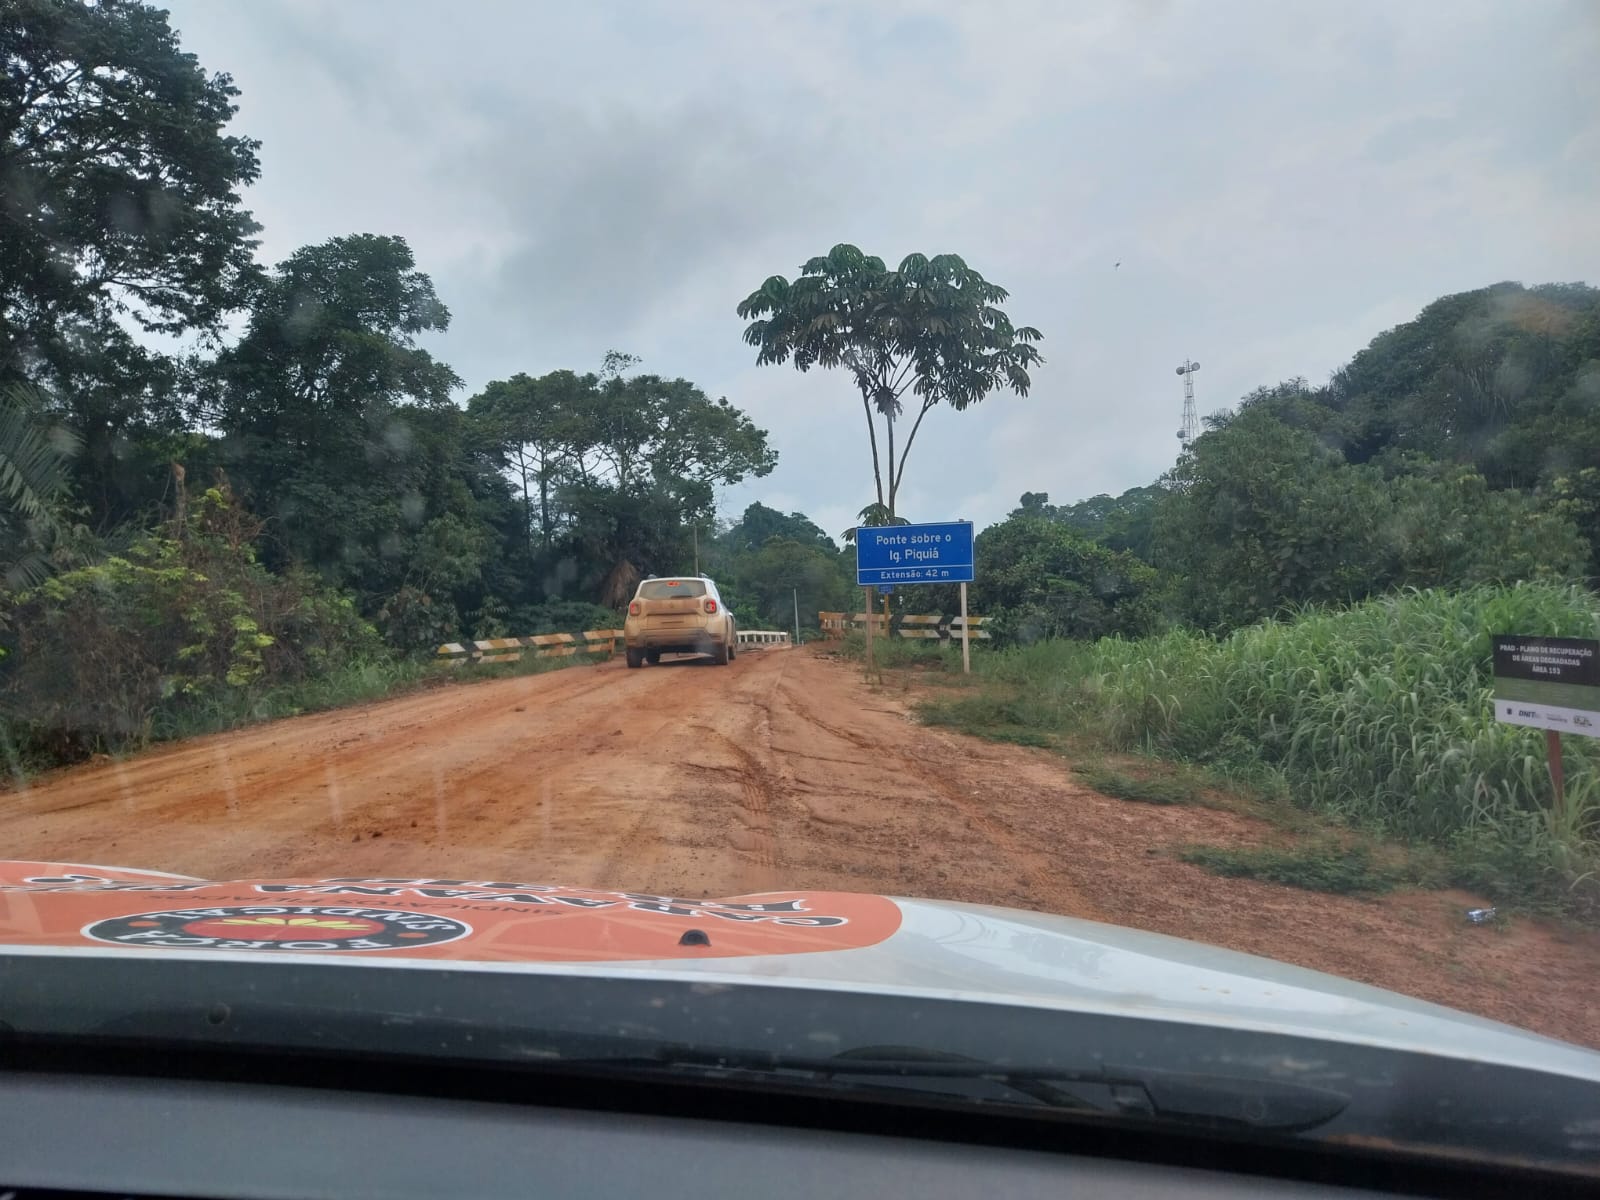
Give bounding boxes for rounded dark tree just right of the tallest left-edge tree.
[198,234,504,640]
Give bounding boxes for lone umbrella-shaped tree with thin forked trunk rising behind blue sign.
[738,245,1043,515]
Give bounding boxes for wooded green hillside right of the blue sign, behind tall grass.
[979,283,1600,635]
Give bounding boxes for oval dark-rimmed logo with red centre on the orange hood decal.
[83,904,472,952]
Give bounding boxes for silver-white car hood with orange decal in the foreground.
[0,862,1600,1082]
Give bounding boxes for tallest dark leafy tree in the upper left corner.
[0,0,259,518]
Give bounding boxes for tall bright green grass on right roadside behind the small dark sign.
[933,584,1600,904]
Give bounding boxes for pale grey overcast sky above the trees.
[156,0,1600,536]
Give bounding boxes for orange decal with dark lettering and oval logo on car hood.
[0,862,901,963]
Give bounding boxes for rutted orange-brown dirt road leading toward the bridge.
[12,650,1600,1045]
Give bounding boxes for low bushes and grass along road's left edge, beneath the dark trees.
[0,488,616,779]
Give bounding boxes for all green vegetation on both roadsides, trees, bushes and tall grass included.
[0,0,1600,940]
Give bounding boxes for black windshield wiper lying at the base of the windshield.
[563,1045,1350,1133]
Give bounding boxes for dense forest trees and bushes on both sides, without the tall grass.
[0,0,1600,784]
